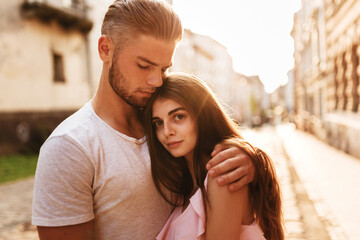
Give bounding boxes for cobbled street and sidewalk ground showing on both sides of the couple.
[0,124,360,240]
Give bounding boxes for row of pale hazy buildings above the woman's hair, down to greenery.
[171,29,268,126]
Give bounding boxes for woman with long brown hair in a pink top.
[144,73,284,240]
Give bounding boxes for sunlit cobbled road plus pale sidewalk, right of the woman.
[243,124,360,240]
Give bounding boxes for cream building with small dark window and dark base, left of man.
[0,0,98,153]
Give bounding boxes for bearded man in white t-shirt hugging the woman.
[32,0,254,240]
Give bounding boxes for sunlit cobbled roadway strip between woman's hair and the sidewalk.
[242,124,331,240]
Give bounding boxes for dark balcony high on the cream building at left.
[21,0,93,34]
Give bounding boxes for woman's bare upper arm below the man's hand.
[206,176,253,240]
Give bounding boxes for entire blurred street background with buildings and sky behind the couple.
[0,0,360,240]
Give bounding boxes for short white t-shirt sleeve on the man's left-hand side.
[32,137,94,226]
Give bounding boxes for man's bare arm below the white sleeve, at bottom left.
[37,220,95,240]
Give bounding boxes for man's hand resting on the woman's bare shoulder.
[206,143,255,192]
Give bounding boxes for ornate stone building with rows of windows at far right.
[292,0,360,157]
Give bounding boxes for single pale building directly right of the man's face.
[171,29,236,105]
